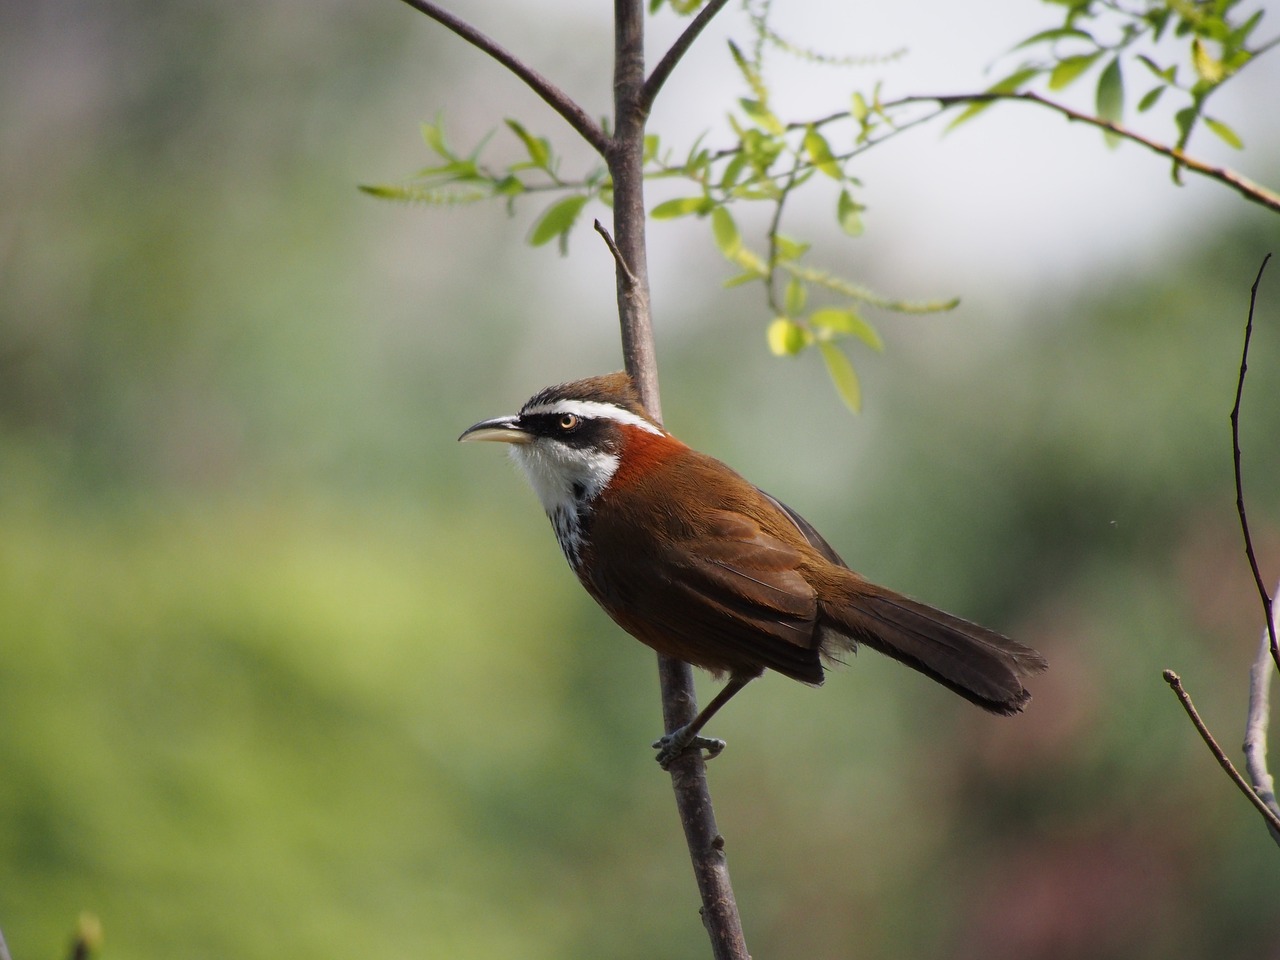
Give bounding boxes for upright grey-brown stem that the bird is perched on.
[607,0,749,960]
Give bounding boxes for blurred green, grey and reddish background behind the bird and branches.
[0,0,1280,960]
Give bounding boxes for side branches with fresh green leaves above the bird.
[362,0,1280,411]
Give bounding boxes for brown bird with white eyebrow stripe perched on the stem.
[458,372,1048,768]
